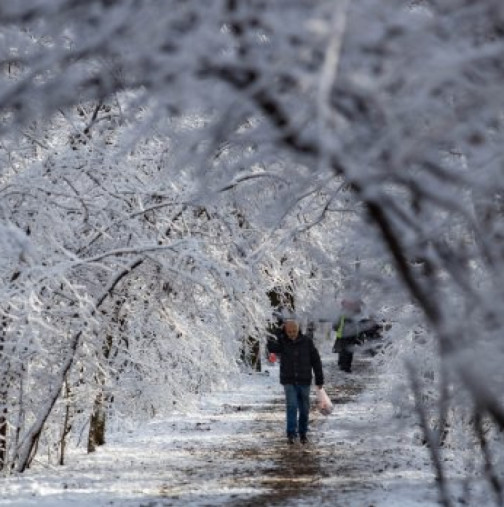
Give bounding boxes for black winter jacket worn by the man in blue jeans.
[268,332,324,386]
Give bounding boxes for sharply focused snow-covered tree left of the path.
[3,100,294,470]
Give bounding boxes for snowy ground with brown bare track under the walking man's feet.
[0,346,448,507]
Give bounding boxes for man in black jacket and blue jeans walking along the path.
[267,319,324,444]
